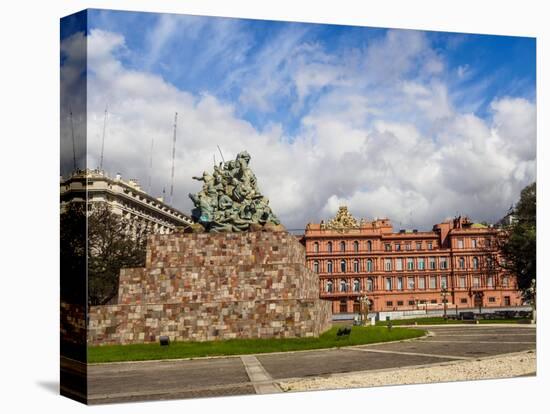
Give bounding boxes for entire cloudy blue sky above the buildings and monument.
[61,10,536,230]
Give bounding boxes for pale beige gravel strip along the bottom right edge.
[278,351,537,391]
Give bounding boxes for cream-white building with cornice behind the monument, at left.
[60,169,193,234]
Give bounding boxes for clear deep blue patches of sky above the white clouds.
[83,10,536,135]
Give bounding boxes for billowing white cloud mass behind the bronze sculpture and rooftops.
[71,27,535,228]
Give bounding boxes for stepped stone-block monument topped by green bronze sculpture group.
[88,152,332,345]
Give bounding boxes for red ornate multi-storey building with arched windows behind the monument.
[304,207,522,313]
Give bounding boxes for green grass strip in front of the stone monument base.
[88,325,425,363]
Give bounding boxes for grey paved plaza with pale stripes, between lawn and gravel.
[88,325,536,404]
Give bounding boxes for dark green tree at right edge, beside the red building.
[499,182,537,303]
